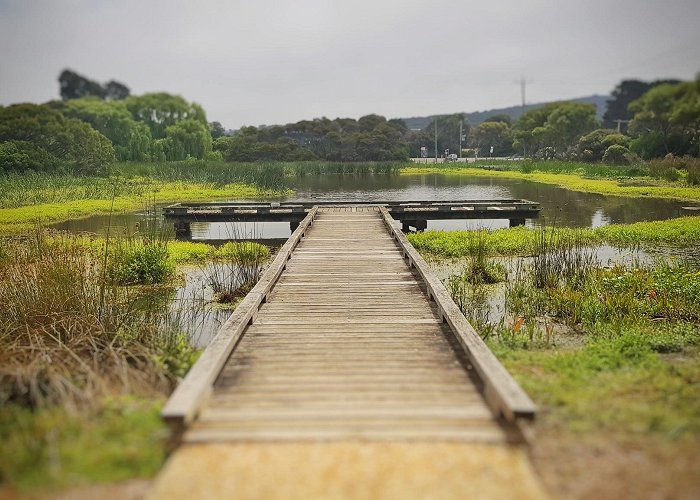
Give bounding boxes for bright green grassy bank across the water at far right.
[401,162,700,201]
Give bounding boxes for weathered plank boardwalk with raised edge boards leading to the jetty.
[163,207,534,443]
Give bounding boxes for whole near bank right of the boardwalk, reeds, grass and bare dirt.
[438,225,700,498]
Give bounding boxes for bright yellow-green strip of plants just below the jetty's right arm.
[408,216,700,257]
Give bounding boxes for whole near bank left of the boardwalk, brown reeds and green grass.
[0,230,269,496]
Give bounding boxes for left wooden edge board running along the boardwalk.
[161,208,317,426]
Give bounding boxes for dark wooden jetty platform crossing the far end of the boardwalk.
[163,199,540,238]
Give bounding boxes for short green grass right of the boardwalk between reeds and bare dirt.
[491,325,700,440]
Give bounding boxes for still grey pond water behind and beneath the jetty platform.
[56,174,683,239]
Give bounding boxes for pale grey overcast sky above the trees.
[0,0,700,128]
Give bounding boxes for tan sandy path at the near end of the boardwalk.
[148,442,546,499]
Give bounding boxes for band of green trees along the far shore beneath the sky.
[0,70,700,174]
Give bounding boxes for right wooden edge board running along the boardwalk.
[379,207,537,422]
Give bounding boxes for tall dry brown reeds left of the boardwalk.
[0,231,197,406]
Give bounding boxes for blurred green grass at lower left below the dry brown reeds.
[0,397,167,493]
